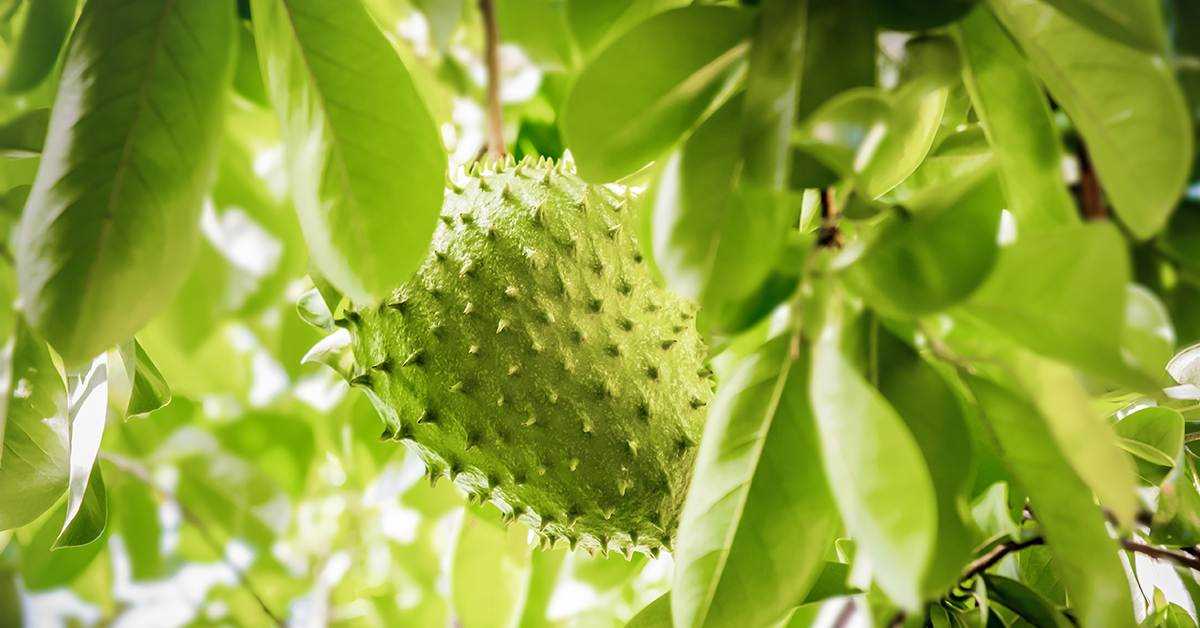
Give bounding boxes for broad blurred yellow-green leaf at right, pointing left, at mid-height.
[965,223,1153,387]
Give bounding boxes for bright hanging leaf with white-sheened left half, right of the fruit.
[810,297,937,610]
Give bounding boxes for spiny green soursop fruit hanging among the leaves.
[337,154,713,555]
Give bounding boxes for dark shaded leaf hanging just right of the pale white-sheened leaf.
[874,329,976,598]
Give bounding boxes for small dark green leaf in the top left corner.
[4,0,76,94]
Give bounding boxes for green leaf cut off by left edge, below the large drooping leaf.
[0,318,70,530]
